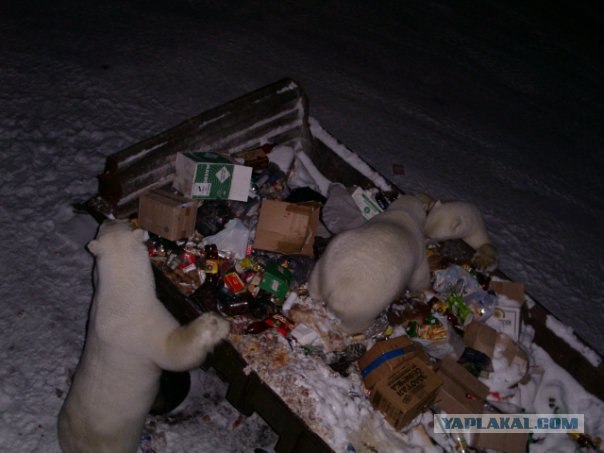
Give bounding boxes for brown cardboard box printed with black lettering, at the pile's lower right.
[369,357,442,430]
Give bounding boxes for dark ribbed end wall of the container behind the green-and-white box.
[99,79,309,212]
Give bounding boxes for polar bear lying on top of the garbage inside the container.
[309,195,430,333]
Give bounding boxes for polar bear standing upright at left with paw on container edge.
[58,220,229,453]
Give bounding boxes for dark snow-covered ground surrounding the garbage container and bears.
[0,0,604,452]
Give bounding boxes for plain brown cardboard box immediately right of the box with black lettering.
[436,357,489,414]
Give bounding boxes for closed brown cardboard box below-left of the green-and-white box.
[138,189,199,241]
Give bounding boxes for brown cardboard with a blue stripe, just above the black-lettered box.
[357,335,421,389]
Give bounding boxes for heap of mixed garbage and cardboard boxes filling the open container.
[120,145,596,451]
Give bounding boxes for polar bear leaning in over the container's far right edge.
[425,201,497,271]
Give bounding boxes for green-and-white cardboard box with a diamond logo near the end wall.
[173,152,252,201]
